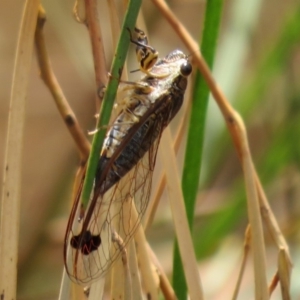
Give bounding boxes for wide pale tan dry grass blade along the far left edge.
[0,0,39,299]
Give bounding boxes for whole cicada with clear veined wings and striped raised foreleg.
[64,28,192,285]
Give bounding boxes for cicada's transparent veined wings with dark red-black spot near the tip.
[65,98,169,285]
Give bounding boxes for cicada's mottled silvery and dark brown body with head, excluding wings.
[96,50,191,193]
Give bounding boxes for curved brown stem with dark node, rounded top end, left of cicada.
[35,7,90,165]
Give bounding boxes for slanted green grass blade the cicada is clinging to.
[81,0,142,208]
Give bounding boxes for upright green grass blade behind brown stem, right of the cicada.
[173,0,223,299]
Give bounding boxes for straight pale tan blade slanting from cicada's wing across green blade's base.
[161,131,203,300]
